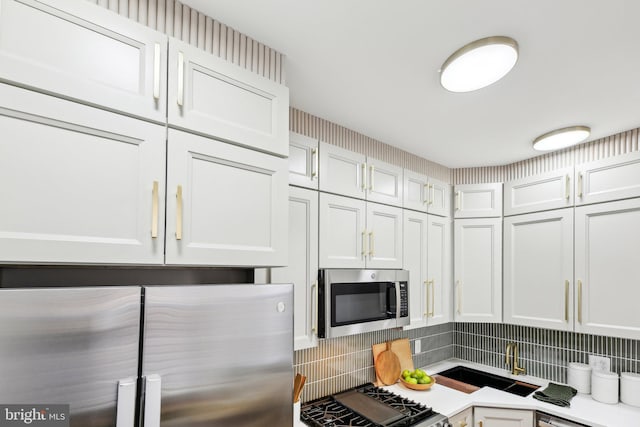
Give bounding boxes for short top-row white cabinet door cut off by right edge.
[576,152,640,206]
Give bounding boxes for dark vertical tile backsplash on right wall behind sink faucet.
[453,323,640,383]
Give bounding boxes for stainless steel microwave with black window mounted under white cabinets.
[318,269,409,338]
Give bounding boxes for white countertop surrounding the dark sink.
[294,359,640,427]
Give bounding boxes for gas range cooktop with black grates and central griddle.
[300,383,451,427]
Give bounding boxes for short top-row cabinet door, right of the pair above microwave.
[367,158,404,207]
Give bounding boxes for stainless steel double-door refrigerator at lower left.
[0,285,293,427]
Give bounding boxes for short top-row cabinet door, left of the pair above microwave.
[319,142,367,199]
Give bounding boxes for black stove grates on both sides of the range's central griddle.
[300,383,436,427]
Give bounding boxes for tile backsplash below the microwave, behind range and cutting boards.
[293,323,453,402]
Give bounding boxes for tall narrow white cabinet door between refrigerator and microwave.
[271,187,318,350]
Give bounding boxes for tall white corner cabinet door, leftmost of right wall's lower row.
[454,218,502,322]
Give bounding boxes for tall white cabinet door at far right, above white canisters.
[575,199,640,339]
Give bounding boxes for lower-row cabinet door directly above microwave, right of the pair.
[366,202,402,268]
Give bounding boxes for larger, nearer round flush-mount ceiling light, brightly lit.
[440,36,518,92]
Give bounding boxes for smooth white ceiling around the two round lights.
[183,0,640,167]
